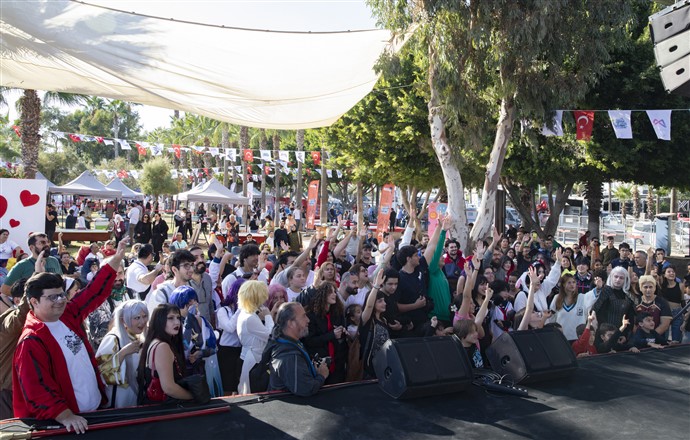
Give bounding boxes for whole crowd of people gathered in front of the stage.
[0,204,690,432]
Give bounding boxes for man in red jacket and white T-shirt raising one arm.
[12,239,129,434]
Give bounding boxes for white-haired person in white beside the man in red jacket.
[96,299,149,408]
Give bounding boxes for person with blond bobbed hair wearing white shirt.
[237,281,273,394]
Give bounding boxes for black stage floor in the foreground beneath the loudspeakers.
[0,345,690,440]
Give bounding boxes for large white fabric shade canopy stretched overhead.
[0,0,397,130]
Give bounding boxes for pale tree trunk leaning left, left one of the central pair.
[428,40,468,253]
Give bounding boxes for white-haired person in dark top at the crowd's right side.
[592,267,635,332]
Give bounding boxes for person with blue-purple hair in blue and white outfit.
[170,286,223,397]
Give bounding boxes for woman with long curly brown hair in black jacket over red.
[302,281,348,384]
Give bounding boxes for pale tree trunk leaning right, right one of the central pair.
[470,96,517,242]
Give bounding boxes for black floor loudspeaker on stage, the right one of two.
[486,328,577,383]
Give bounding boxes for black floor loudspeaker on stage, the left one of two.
[374,336,473,399]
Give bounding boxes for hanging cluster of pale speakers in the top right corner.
[649,0,690,97]
